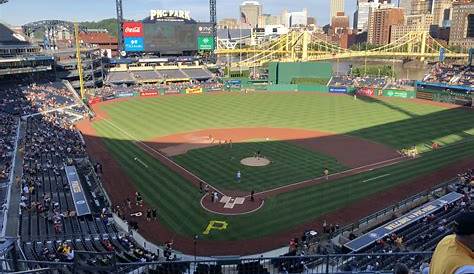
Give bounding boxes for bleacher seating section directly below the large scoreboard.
[106,68,213,84]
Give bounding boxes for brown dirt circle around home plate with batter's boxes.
[201,193,264,215]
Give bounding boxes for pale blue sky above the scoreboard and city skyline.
[0,0,356,25]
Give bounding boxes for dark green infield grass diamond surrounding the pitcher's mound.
[173,141,346,192]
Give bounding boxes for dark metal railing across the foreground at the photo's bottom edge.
[0,252,432,274]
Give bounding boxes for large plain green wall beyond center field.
[268,62,332,85]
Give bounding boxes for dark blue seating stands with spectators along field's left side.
[0,79,170,272]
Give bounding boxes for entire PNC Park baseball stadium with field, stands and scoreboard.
[0,0,474,274]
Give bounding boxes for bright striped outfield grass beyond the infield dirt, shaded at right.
[98,93,474,151]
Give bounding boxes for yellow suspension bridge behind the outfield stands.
[216,31,468,67]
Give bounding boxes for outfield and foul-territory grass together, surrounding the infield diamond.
[94,94,474,240]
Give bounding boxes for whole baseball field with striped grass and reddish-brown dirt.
[79,93,474,255]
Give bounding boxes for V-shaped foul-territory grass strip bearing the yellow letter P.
[93,117,474,240]
